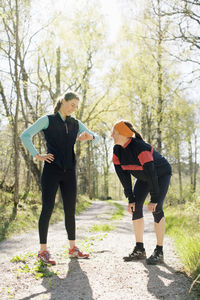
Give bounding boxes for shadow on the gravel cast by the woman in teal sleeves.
[20,259,94,300]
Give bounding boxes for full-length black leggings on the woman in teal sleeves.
[39,163,77,244]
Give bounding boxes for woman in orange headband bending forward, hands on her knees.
[112,121,172,264]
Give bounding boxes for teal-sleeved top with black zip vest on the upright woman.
[20,112,97,169]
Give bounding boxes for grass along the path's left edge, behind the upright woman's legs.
[0,193,92,241]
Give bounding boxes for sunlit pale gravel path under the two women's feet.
[0,201,197,300]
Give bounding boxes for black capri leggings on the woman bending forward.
[132,175,171,223]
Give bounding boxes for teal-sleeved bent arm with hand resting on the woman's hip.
[20,116,49,156]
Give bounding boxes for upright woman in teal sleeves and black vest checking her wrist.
[20,93,95,265]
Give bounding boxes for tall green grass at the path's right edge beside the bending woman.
[165,205,200,292]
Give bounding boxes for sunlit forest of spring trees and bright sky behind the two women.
[0,0,200,290]
